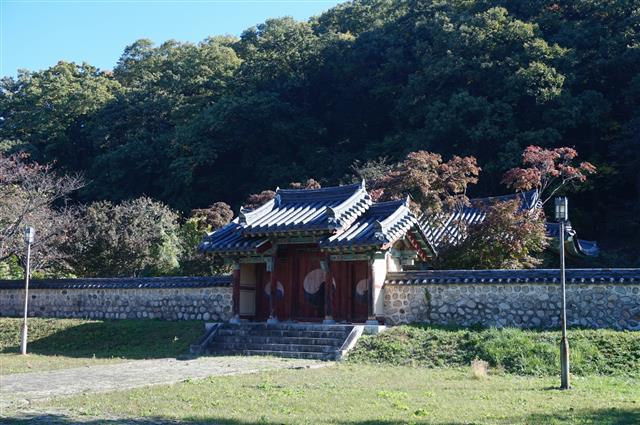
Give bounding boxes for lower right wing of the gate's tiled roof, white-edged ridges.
[320,200,418,249]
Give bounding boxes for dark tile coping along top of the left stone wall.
[0,276,231,290]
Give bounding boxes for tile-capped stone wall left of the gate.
[0,276,232,321]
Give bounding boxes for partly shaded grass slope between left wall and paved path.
[0,318,204,375]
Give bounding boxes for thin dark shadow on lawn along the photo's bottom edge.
[5,409,640,425]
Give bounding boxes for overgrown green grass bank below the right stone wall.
[349,325,640,376]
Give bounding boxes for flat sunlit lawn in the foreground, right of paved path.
[14,363,640,425]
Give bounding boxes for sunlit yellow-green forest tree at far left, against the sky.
[0,61,121,167]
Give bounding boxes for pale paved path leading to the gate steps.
[0,357,329,411]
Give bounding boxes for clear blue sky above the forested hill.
[0,0,340,76]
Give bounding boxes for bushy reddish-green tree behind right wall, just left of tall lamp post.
[436,200,548,269]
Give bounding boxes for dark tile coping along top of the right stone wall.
[385,269,640,285]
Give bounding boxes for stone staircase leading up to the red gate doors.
[206,323,362,360]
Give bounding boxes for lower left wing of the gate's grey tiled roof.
[198,218,269,254]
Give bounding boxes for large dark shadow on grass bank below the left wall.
[0,319,204,359]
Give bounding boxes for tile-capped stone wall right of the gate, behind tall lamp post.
[385,269,640,330]
